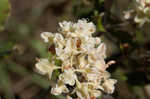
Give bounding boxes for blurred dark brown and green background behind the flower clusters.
[0,0,150,99]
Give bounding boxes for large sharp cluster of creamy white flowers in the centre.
[35,19,117,99]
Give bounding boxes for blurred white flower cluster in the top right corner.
[125,0,150,26]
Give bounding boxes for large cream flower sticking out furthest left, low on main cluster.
[35,59,60,78]
